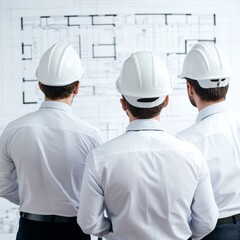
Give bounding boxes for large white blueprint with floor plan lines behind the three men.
[0,0,240,240]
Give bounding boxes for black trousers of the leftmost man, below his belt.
[17,217,91,240]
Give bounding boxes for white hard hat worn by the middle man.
[116,51,172,108]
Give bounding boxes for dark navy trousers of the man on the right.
[203,221,240,240]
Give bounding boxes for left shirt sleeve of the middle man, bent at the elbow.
[77,152,111,236]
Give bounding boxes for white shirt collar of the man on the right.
[196,101,228,122]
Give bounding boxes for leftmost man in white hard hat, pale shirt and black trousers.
[0,44,101,240]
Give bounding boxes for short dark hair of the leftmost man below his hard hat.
[41,81,78,100]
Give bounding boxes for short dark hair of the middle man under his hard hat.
[122,96,165,119]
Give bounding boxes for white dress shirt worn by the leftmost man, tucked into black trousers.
[0,101,101,216]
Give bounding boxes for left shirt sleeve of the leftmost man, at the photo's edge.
[0,132,20,204]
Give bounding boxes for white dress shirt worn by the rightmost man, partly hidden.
[177,102,240,218]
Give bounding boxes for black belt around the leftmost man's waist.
[20,212,77,223]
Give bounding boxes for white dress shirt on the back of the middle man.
[79,120,218,240]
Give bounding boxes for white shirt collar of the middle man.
[126,119,162,132]
